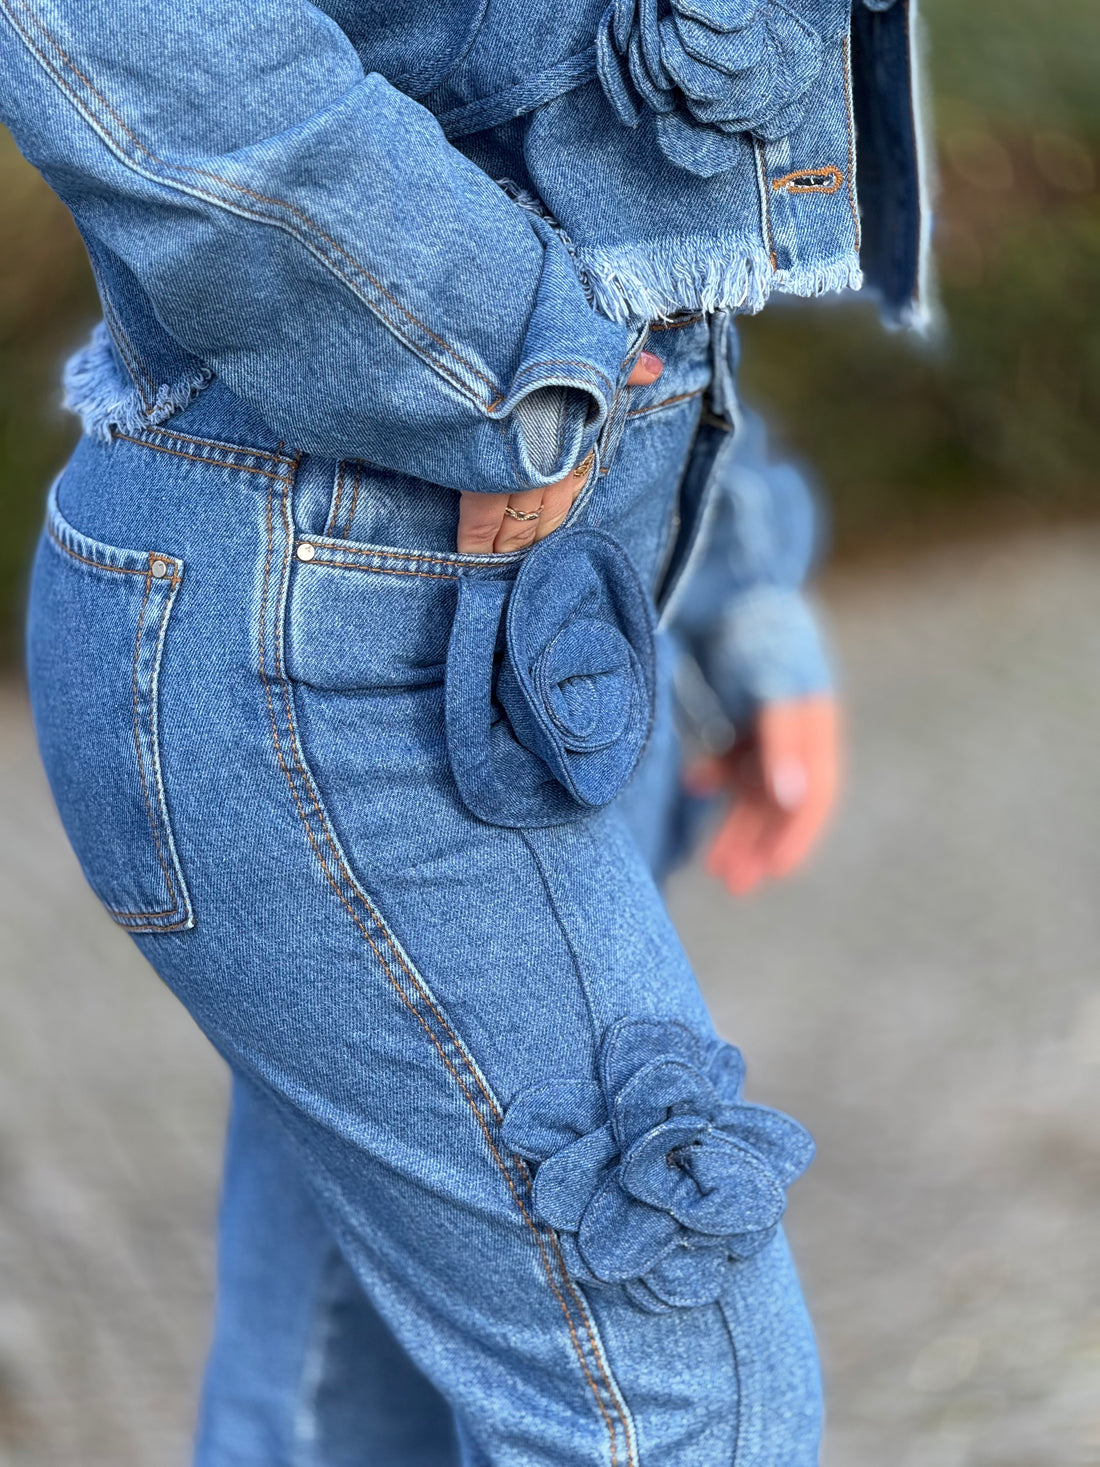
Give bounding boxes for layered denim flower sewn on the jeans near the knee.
[503,1020,814,1309]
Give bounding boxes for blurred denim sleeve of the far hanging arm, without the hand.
[670,412,833,726]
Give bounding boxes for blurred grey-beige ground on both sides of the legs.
[0,528,1100,1467]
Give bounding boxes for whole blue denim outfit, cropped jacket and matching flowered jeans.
[0,0,925,1467]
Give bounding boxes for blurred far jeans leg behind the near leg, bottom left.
[195,1077,459,1467]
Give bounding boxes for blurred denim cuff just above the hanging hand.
[701,587,833,725]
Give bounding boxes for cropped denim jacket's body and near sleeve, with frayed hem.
[0,0,923,490]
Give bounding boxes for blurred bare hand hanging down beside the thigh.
[686,697,840,896]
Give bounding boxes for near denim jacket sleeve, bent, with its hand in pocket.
[0,0,628,491]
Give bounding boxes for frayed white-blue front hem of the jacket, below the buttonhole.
[576,239,862,321]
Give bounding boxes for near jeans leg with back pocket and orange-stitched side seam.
[31,372,817,1467]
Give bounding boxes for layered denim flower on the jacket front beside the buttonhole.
[597,0,823,178]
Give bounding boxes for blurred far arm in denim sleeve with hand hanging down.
[672,414,839,895]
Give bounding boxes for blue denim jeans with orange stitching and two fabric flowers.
[29,326,820,1467]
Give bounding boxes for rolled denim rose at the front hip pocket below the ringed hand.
[446,530,654,826]
